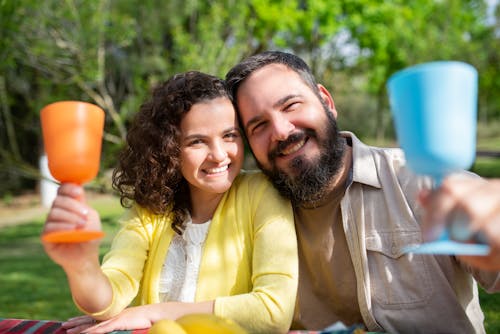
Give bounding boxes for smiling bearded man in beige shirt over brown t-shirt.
[226,52,500,333]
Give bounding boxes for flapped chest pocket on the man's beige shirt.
[366,231,433,309]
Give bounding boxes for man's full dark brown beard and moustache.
[257,106,345,205]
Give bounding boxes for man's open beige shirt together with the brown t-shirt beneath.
[294,132,500,333]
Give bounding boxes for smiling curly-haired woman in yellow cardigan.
[43,72,297,333]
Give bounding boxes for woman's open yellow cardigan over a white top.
[87,173,298,333]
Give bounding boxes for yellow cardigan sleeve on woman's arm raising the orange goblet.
[83,209,149,319]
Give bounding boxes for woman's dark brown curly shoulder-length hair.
[113,71,230,234]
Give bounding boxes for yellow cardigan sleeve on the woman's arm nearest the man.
[214,179,298,333]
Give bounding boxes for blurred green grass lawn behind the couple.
[0,197,500,333]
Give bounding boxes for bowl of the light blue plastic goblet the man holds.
[387,61,478,184]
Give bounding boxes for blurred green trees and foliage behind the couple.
[0,0,500,201]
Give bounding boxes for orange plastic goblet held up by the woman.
[40,101,104,243]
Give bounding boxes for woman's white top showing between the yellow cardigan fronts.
[159,219,211,302]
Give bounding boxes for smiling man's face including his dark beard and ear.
[237,64,343,204]
